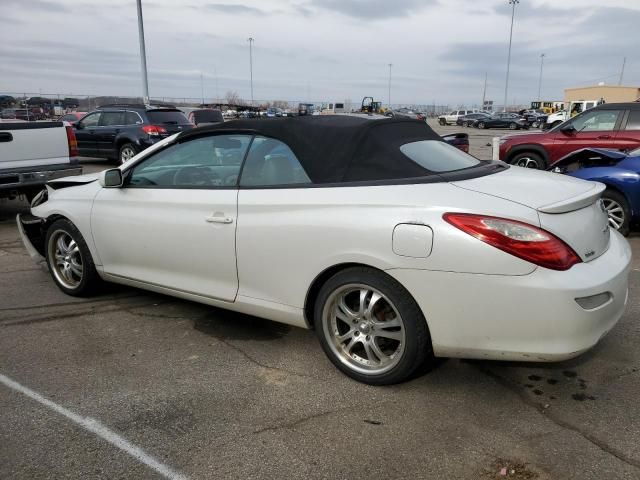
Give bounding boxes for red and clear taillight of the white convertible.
[443,213,581,270]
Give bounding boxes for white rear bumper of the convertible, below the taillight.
[388,232,631,361]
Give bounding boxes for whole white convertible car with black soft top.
[18,116,631,385]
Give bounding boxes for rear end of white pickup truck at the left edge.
[0,121,82,201]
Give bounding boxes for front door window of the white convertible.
[126,135,251,189]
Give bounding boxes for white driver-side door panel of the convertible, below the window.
[91,188,238,301]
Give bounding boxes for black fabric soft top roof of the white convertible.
[178,115,442,183]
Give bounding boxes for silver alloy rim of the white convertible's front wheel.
[47,230,82,289]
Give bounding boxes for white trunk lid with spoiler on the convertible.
[452,166,605,213]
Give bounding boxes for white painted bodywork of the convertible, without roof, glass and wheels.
[27,129,630,360]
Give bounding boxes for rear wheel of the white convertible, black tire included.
[314,267,433,385]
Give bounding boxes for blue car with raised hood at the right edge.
[550,148,640,236]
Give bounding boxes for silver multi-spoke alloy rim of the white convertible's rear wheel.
[322,284,406,375]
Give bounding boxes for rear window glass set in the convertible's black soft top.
[400,140,480,172]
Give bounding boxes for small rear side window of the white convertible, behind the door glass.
[240,137,311,187]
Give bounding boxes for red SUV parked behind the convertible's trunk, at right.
[500,103,640,170]
